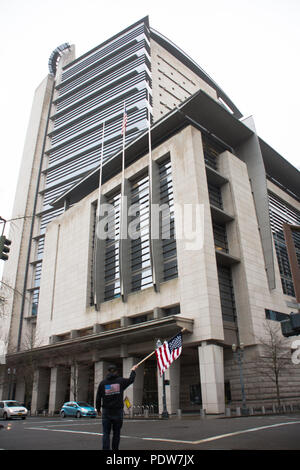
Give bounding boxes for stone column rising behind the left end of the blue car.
[49,367,70,415]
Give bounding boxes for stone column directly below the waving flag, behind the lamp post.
[157,357,180,414]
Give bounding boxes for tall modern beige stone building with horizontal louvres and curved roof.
[0,17,300,414]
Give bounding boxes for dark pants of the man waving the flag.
[102,408,123,450]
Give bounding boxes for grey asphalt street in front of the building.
[0,414,300,452]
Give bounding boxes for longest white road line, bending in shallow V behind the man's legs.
[26,421,300,445]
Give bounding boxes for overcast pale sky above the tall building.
[0,0,300,229]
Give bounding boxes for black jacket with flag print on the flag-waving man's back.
[96,371,136,411]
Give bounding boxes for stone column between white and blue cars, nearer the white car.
[31,368,50,414]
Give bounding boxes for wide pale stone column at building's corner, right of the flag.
[198,341,225,414]
